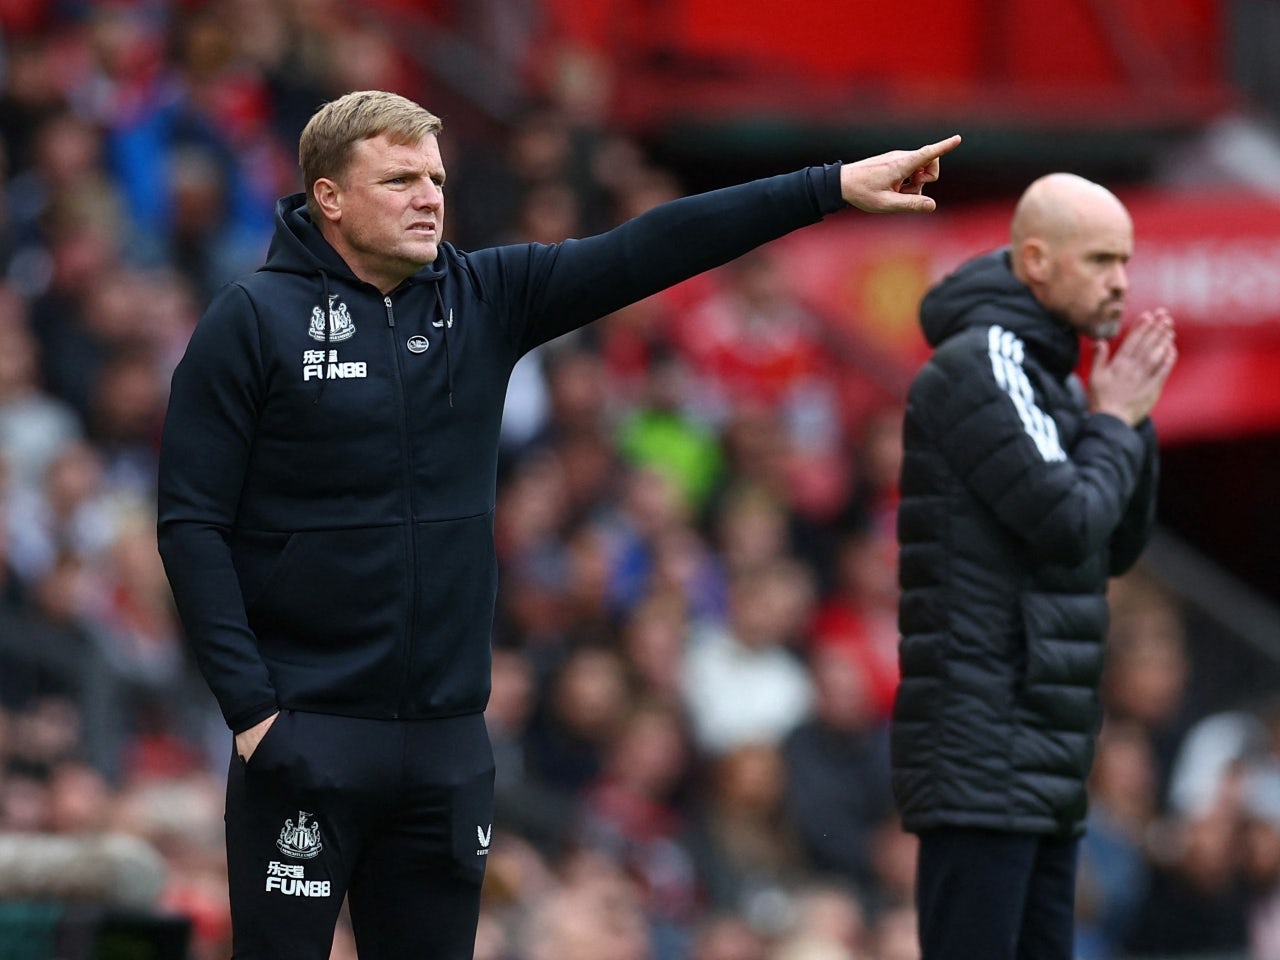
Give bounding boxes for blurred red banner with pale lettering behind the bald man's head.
[732,193,1280,443]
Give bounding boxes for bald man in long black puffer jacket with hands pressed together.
[892,173,1178,960]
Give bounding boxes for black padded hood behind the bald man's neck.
[920,247,1080,376]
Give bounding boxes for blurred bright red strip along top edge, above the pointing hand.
[540,0,1230,128]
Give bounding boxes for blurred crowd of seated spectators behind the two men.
[0,0,1280,960]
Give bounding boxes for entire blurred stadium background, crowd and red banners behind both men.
[0,0,1280,960]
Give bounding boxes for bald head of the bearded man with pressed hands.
[1009,173,1133,339]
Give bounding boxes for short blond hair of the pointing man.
[298,90,444,223]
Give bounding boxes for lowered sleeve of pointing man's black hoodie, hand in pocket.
[157,285,276,732]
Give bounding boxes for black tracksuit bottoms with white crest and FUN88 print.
[227,710,494,960]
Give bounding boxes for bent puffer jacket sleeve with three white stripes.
[919,325,1147,566]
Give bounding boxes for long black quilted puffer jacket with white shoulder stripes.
[892,251,1157,835]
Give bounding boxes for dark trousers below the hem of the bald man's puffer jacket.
[915,828,1079,960]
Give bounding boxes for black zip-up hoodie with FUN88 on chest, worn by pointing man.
[159,164,844,732]
